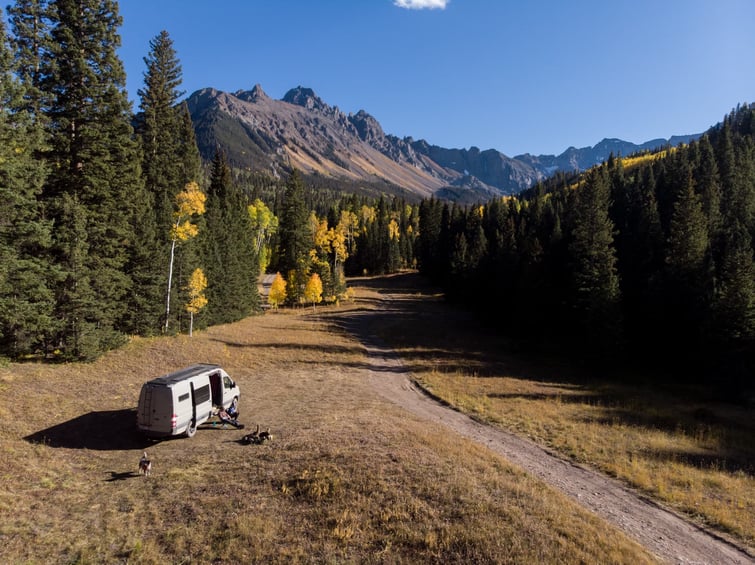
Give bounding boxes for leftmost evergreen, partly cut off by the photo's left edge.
[0,9,55,357]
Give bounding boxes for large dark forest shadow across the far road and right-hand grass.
[336,274,755,474]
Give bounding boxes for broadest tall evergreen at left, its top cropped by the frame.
[41,0,143,358]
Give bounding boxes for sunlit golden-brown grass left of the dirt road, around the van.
[0,282,652,564]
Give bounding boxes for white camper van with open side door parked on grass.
[136,364,240,437]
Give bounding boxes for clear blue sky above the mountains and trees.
[119,0,755,156]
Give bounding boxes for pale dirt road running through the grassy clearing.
[342,286,755,565]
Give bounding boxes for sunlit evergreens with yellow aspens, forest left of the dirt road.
[0,0,418,360]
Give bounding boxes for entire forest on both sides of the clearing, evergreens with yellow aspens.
[0,0,755,400]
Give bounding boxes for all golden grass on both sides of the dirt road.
[0,276,755,564]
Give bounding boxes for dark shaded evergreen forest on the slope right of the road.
[417,104,755,394]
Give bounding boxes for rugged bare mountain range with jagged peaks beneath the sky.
[187,85,700,202]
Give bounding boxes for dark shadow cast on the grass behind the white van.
[24,408,155,451]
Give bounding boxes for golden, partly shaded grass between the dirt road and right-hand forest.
[362,272,755,547]
